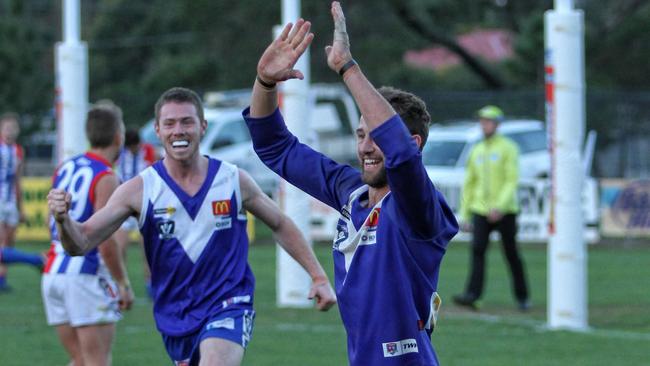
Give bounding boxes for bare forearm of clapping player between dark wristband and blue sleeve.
[343,65,395,130]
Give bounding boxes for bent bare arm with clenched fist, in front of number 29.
[47,177,142,255]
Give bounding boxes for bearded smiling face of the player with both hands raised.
[356,117,388,188]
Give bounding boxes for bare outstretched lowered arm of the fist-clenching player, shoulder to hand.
[239,170,336,311]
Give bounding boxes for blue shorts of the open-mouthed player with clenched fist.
[162,309,255,366]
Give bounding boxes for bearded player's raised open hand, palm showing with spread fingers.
[257,19,314,84]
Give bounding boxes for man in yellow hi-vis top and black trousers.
[453,105,530,311]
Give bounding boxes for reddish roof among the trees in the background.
[404,29,514,70]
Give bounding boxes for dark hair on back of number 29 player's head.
[86,105,122,148]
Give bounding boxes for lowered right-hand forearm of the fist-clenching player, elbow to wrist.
[273,217,327,281]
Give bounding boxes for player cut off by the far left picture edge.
[0,113,25,291]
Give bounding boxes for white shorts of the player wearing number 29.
[41,273,122,327]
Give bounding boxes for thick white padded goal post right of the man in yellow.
[544,0,588,331]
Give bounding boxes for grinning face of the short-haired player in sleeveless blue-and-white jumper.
[155,101,207,161]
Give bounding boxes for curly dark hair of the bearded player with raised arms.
[377,86,431,150]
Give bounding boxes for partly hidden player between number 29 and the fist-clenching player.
[115,128,160,297]
